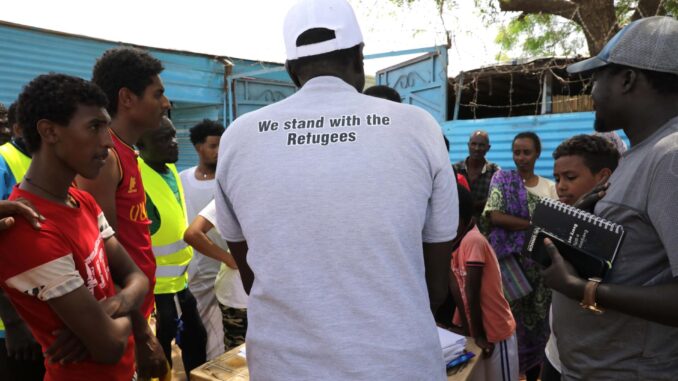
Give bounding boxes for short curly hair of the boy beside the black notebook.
[553,134,619,174]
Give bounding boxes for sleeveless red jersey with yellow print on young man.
[111,130,156,318]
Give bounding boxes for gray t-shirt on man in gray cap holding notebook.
[553,118,678,380]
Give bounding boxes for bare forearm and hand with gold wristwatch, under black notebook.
[543,240,678,327]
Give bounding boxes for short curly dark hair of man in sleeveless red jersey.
[92,47,165,117]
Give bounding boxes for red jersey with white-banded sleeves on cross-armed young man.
[0,186,134,381]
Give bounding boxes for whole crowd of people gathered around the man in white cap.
[0,0,678,381]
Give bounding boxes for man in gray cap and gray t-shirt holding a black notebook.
[544,17,678,380]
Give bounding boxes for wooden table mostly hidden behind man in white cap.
[191,338,481,381]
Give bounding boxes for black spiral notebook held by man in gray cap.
[523,198,624,278]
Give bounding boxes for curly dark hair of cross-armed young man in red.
[17,73,108,152]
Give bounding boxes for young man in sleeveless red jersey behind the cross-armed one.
[77,48,170,377]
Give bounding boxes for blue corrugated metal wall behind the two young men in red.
[0,24,230,169]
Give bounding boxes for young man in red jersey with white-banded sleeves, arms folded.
[0,74,148,381]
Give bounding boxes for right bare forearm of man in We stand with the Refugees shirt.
[424,241,454,315]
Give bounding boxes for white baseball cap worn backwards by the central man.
[283,0,363,60]
